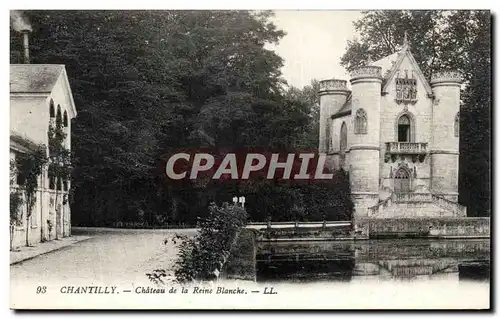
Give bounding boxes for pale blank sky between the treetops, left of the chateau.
[268,10,361,88]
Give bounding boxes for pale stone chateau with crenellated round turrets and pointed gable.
[319,35,466,218]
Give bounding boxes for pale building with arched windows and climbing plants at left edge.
[10,64,76,248]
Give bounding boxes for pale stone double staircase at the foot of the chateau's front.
[368,192,467,218]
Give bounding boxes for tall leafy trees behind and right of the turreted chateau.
[342,10,491,216]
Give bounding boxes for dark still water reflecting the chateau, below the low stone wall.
[257,239,490,281]
